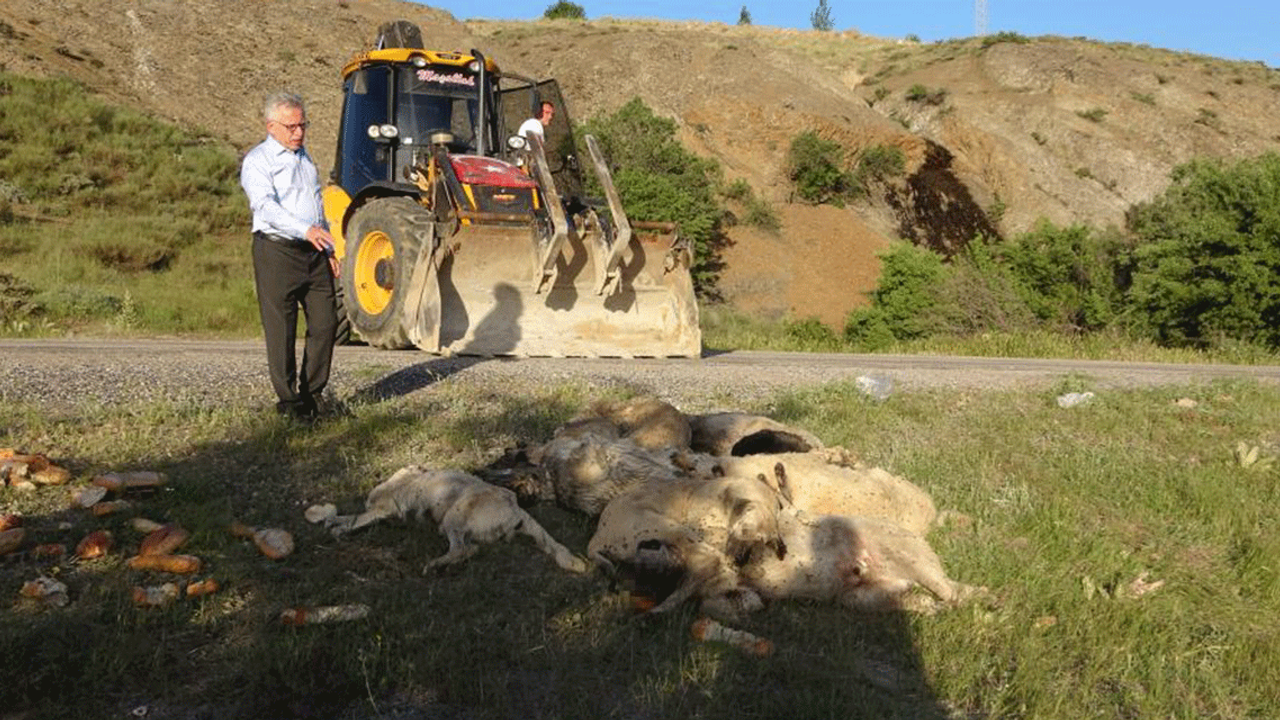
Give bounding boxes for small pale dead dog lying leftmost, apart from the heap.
[325,465,589,573]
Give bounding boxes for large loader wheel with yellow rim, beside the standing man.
[342,197,431,350]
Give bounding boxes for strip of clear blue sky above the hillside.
[422,0,1280,68]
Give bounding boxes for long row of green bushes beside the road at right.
[845,154,1280,351]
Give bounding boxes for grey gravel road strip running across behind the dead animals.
[0,340,1280,411]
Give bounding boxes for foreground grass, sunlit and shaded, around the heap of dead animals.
[0,377,1280,719]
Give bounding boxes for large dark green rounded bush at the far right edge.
[1129,152,1280,348]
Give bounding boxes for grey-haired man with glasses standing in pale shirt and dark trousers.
[241,92,338,419]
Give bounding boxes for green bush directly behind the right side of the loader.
[577,97,724,297]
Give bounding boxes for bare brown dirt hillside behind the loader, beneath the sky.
[0,0,1280,325]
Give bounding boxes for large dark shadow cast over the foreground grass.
[0,359,947,720]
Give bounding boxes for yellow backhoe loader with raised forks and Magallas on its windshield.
[324,22,701,357]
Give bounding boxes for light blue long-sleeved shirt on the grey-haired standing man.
[241,136,328,240]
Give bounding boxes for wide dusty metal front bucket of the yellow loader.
[410,223,701,357]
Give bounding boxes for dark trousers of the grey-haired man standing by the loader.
[253,233,338,416]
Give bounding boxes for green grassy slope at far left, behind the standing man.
[0,73,257,337]
